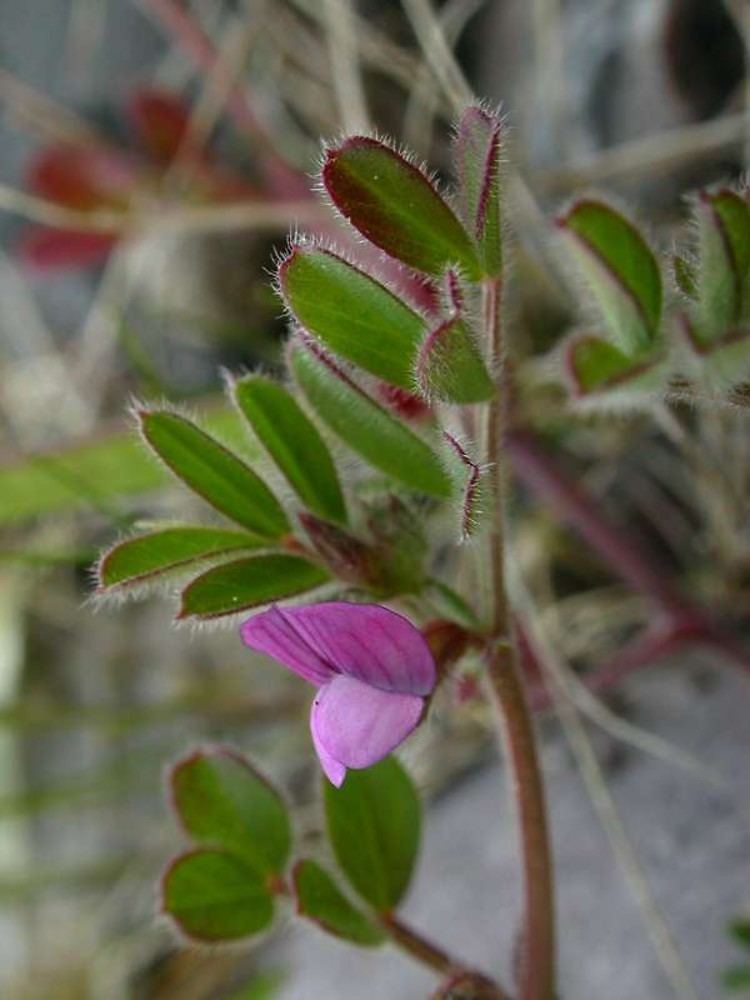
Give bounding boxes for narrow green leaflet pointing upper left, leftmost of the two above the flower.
[139,410,289,538]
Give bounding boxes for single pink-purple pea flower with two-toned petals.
[240,601,435,788]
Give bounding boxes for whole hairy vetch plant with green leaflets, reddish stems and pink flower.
[98,106,750,1000]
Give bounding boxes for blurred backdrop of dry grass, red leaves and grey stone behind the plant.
[0,0,750,1000]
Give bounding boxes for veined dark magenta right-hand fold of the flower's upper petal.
[268,601,435,695]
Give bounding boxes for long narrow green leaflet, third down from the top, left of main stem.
[291,345,451,499]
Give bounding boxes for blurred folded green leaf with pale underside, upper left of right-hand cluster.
[558,200,662,354]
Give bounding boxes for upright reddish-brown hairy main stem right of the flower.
[482,279,555,1000]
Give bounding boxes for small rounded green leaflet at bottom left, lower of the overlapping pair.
[162,848,273,943]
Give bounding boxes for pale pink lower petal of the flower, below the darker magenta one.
[310,674,424,785]
